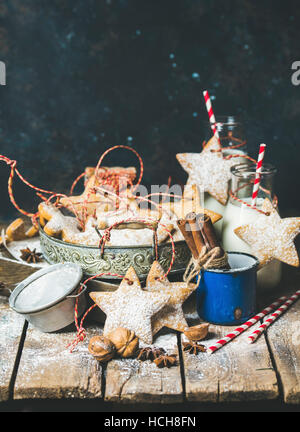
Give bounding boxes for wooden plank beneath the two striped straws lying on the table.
[182,326,279,402]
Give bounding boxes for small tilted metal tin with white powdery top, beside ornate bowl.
[9,263,86,333]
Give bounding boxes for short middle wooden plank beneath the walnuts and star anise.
[105,332,183,403]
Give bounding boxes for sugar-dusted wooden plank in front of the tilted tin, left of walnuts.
[14,328,102,399]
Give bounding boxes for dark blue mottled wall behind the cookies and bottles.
[0,0,300,219]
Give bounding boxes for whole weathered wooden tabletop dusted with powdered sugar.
[0,228,300,404]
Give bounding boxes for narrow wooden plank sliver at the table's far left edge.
[0,297,25,402]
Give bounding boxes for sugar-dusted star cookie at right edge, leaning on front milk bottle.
[234,198,300,267]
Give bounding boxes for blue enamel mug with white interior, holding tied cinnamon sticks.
[197,252,259,325]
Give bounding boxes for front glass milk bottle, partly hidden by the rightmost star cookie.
[222,164,281,289]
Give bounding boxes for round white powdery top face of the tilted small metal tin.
[9,263,83,314]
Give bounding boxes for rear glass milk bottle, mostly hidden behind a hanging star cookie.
[204,116,247,237]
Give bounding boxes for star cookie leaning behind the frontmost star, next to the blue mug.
[145,261,196,335]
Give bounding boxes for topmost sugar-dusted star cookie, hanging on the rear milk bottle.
[176,137,236,205]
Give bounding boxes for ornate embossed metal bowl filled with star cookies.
[40,228,191,280]
